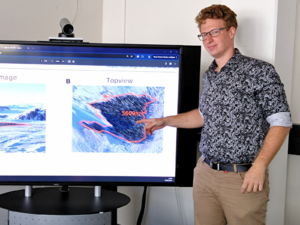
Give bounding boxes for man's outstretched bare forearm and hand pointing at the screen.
[136,109,203,135]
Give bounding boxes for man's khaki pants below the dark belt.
[193,158,269,225]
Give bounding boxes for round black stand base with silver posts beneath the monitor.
[0,186,130,225]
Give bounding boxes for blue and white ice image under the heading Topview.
[72,85,164,153]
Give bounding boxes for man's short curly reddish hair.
[195,5,238,29]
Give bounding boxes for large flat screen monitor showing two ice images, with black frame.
[0,41,200,186]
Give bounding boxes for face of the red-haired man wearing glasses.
[200,19,235,59]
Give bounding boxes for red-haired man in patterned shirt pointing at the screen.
[137,5,291,225]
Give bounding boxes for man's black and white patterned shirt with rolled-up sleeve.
[199,49,291,163]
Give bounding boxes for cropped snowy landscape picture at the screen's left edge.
[0,83,46,153]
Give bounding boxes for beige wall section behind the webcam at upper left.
[0,0,103,42]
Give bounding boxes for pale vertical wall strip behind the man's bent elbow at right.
[267,0,297,224]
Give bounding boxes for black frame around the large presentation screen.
[0,41,201,187]
